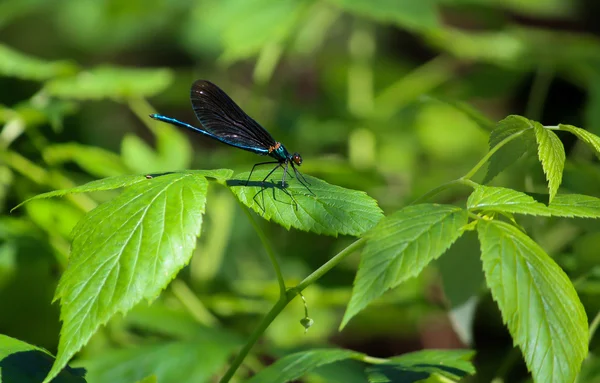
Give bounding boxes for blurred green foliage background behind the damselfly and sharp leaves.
[0,0,600,382]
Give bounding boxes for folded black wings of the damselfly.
[190,80,275,154]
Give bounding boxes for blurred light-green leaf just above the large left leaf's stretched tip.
[43,142,129,177]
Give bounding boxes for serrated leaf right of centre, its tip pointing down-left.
[340,204,468,327]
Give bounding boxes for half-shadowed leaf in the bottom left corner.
[0,334,85,383]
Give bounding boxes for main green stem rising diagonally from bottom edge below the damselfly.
[220,238,366,383]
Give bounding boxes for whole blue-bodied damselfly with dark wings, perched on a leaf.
[150,80,312,193]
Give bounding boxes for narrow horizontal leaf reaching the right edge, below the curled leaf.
[467,186,600,218]
